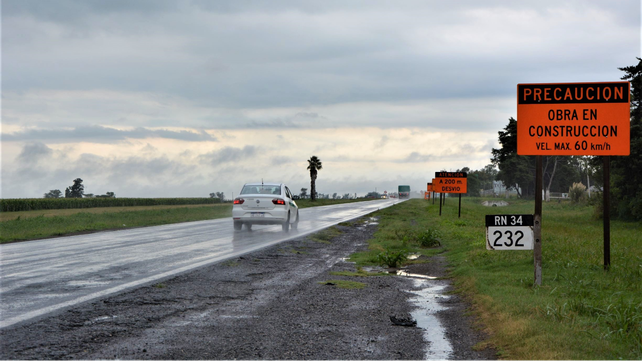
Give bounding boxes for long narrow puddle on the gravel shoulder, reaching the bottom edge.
[410,276,453,360]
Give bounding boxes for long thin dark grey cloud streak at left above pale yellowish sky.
[2,125,216,143]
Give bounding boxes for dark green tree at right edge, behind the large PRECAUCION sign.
[611,58,642,220]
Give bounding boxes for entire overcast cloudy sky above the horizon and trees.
[0,0,641,198]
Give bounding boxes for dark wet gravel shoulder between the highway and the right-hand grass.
[0,215,496,360]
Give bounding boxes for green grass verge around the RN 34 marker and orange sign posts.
[351,198,642,360]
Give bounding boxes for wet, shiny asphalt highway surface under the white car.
[0,199,397,328]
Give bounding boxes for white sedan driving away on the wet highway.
[232,183,299,232]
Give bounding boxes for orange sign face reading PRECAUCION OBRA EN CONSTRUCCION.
[517,81,631,156]
